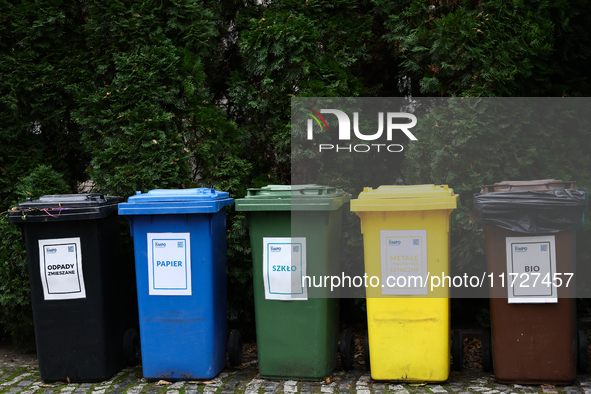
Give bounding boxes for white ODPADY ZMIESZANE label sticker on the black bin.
[39,238,86,300]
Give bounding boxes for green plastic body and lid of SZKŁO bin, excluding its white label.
[236,185,348,380]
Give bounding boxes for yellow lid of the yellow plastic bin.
[351,185,459,212]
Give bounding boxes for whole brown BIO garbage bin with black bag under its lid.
[475,179,587,384]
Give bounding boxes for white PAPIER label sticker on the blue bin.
[148,233,192,295]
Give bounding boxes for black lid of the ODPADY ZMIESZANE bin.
[8,193,123,224]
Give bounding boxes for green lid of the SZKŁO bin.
[236,185,351,211]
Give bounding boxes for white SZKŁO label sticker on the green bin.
[263,237,308,300]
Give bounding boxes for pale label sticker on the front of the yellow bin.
[380,230,428,295]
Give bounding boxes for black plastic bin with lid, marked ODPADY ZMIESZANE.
[9,195,125,382]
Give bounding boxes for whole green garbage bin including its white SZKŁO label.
[236,185,353,380]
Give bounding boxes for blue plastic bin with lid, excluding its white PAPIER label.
[119,189,233,380]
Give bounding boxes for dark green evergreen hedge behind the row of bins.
[0,0,591,347]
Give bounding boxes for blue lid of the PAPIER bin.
[119,187,234,215]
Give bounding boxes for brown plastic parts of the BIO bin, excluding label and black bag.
[481,180,577,384]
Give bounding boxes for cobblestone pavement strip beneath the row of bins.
[0,354,591,394]
